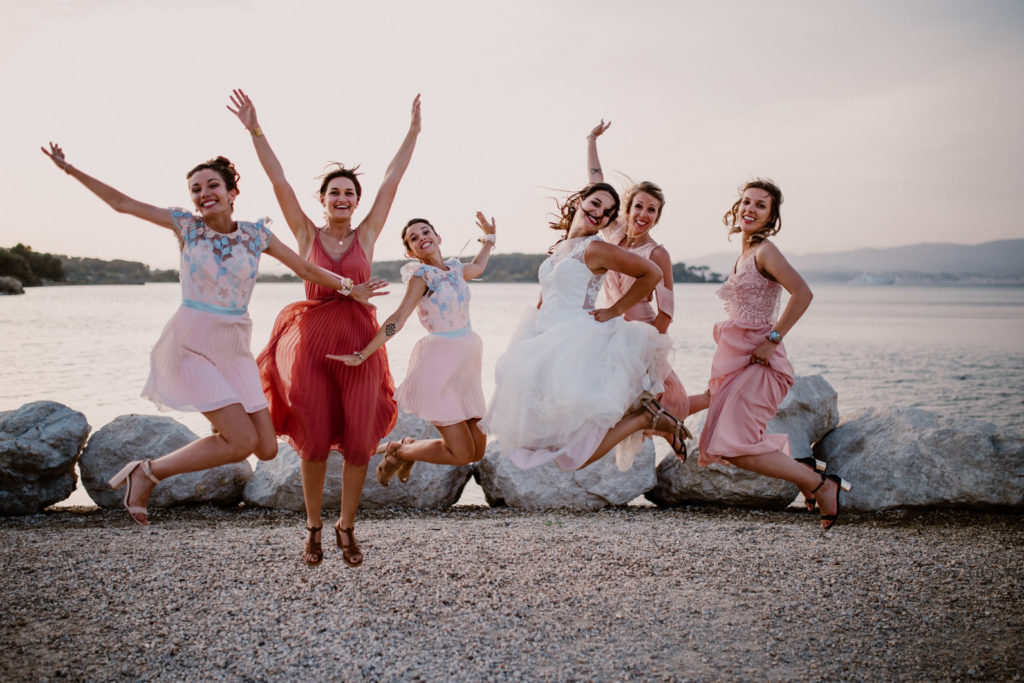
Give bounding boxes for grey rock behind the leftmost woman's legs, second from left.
[79,415,253,508]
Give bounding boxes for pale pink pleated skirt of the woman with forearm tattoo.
[394,332,486,426]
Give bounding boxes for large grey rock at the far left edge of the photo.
[0,400,90,515]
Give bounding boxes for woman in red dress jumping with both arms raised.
[228,90,420,566]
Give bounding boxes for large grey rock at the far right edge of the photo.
[815,408,1024,511]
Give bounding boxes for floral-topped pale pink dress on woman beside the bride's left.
[395,258,486,426]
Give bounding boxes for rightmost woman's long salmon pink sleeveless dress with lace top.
[698,246,793,465]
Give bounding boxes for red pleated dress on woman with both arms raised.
[257,234,398,466]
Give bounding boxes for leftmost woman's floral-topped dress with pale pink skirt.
[142,208,273,413]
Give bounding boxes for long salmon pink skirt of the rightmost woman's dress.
[698,321,793,465]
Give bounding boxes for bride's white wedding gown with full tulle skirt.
[480,236,671,471]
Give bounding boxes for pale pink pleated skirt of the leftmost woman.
[142,306,266,413]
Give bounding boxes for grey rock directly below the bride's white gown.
[474,439,655,510]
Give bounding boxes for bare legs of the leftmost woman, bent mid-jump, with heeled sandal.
[123,403,278,518]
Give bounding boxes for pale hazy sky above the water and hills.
[0,0,1024,271]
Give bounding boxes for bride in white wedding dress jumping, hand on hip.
[480,182,689,471]
